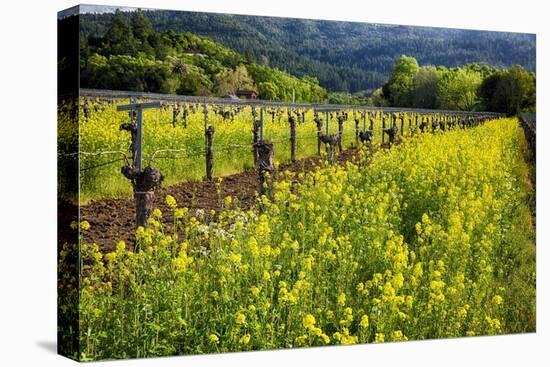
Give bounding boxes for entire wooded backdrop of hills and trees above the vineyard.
[80,11,536,114]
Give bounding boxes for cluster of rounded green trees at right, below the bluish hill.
[373,56,536,115]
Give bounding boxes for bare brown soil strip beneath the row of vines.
[75,149,362,251]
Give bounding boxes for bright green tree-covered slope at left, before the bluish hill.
[80,11,327,102]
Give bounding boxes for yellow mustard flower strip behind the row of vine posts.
[59,101,390,203]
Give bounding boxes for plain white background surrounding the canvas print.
[0,0,550,367]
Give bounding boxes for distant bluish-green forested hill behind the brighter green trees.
[81,10,536,92]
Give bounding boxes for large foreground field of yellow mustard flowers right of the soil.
[59,118,536,360]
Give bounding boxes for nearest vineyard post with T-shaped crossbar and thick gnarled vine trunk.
[117,102,163,239]
